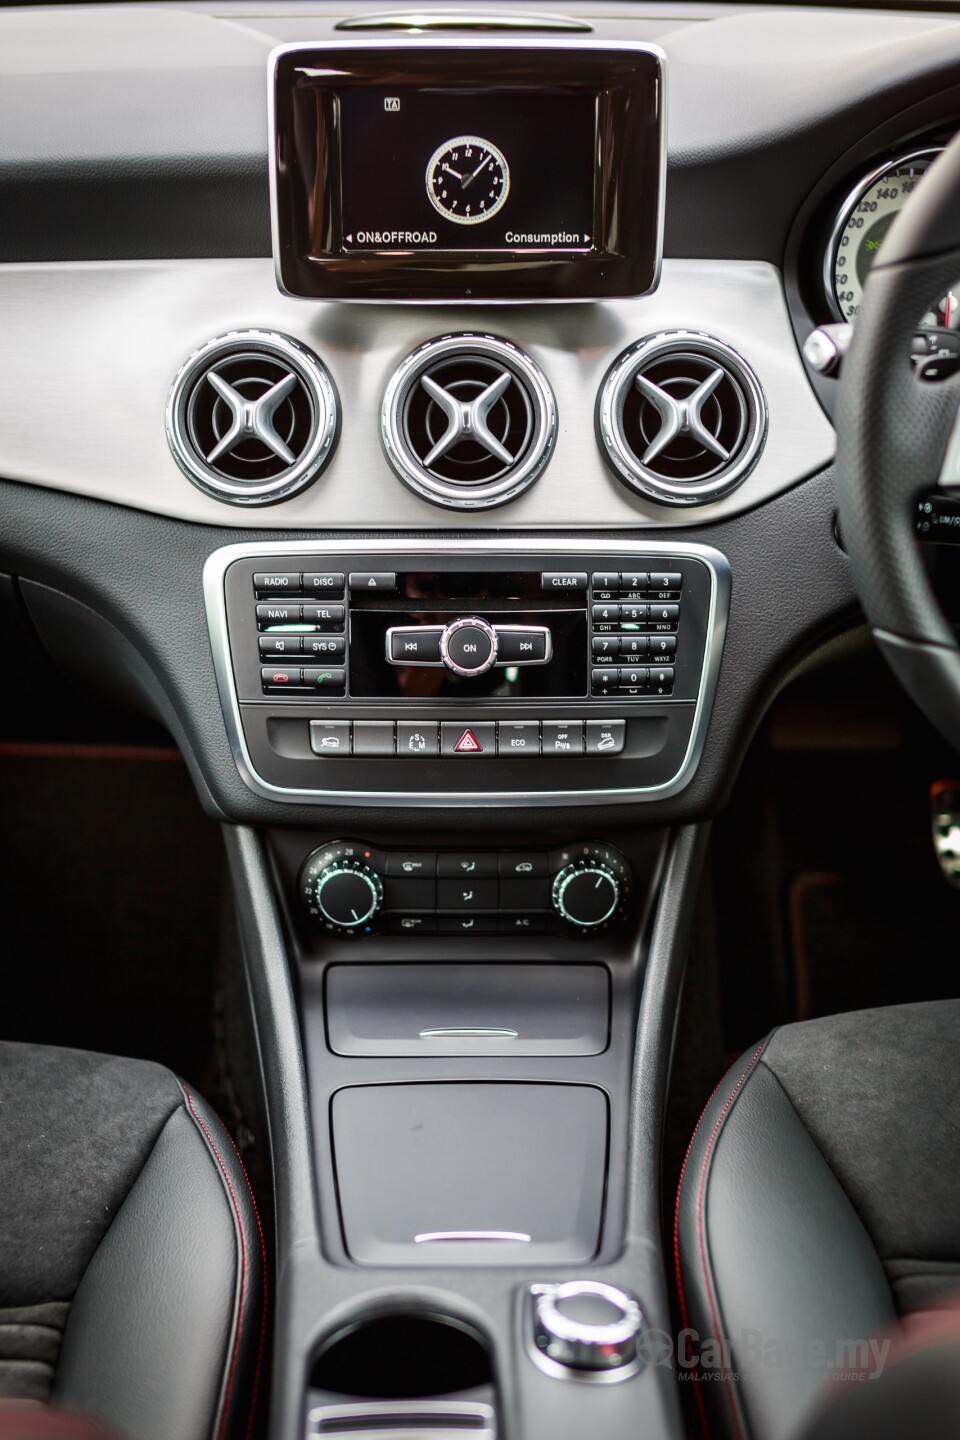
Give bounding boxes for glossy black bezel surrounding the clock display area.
[271,40,664,301]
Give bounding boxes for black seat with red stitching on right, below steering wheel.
[676,1001,960,1440]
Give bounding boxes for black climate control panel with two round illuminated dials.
[299,840,633,939]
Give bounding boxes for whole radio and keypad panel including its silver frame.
[204,537,730,806]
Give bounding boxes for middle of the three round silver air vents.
[383,336,557,510]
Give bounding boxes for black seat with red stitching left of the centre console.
[0,1044,263,1440]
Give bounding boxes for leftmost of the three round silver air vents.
[167,330,340,505]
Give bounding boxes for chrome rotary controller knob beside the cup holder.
[531,1280,643,1380]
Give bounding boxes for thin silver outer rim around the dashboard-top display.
[266,33,668,305]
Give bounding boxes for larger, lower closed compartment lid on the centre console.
[331,1081,609,1266]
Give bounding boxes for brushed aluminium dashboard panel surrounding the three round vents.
[0,258,835,534]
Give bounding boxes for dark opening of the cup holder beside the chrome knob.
[311,1315,494,1400]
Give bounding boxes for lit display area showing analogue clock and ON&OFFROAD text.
[333,89,597,252]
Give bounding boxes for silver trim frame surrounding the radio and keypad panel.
[203,536,731,809]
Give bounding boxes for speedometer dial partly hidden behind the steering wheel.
[825,150,944,327]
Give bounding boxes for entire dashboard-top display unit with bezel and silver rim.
[271,39,664,300]
